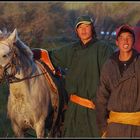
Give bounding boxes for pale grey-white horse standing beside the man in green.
[0,30,65,138]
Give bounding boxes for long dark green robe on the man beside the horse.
[50,40,114,137]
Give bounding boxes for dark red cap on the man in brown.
[116,24,135,39]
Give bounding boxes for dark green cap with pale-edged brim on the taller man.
[75,15,93,28]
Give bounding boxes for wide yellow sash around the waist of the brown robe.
[107,111,140,126]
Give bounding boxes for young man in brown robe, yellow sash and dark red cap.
[96,25,140,138]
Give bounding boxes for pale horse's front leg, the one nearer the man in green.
[35,120,45,138]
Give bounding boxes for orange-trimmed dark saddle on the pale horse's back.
[32,48,67,136]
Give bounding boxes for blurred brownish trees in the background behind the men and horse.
[0,2,140,48]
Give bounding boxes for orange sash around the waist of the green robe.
[70,95,95,109]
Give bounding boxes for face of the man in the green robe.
[77,23,92,44]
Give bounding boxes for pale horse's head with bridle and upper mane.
[0,29,32,82]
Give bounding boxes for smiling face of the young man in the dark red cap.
[116,32,134,52]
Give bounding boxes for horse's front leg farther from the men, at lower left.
[12,122,24,137]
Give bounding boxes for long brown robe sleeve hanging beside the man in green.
[96,62,111,135]
